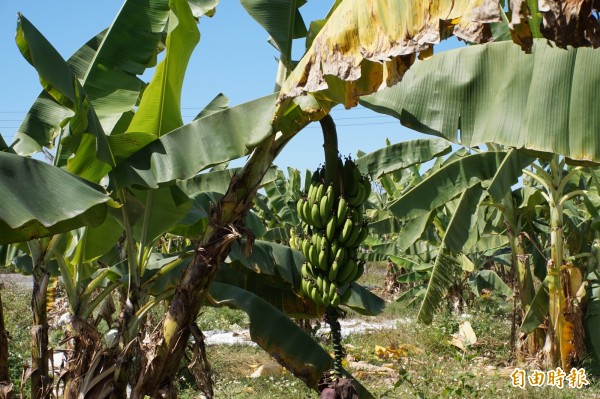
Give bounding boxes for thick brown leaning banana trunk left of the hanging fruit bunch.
[131,137,291,399]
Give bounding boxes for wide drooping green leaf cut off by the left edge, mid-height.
[0,152,110,244]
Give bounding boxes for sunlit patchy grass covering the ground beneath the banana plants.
[2,268,600,399]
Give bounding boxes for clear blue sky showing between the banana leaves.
[0,0,456,170]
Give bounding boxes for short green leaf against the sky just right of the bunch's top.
[356,139,452,178]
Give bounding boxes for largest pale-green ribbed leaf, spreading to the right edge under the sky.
[362,40,600,161]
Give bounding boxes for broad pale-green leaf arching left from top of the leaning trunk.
[112,95,275,188]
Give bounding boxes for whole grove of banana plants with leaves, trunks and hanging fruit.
[0,0,600,399]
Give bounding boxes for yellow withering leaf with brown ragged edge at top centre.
[280,0,500,110]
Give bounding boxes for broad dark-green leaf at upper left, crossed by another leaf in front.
[14,0,169,155]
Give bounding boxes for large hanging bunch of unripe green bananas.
[290,158,371,308]
